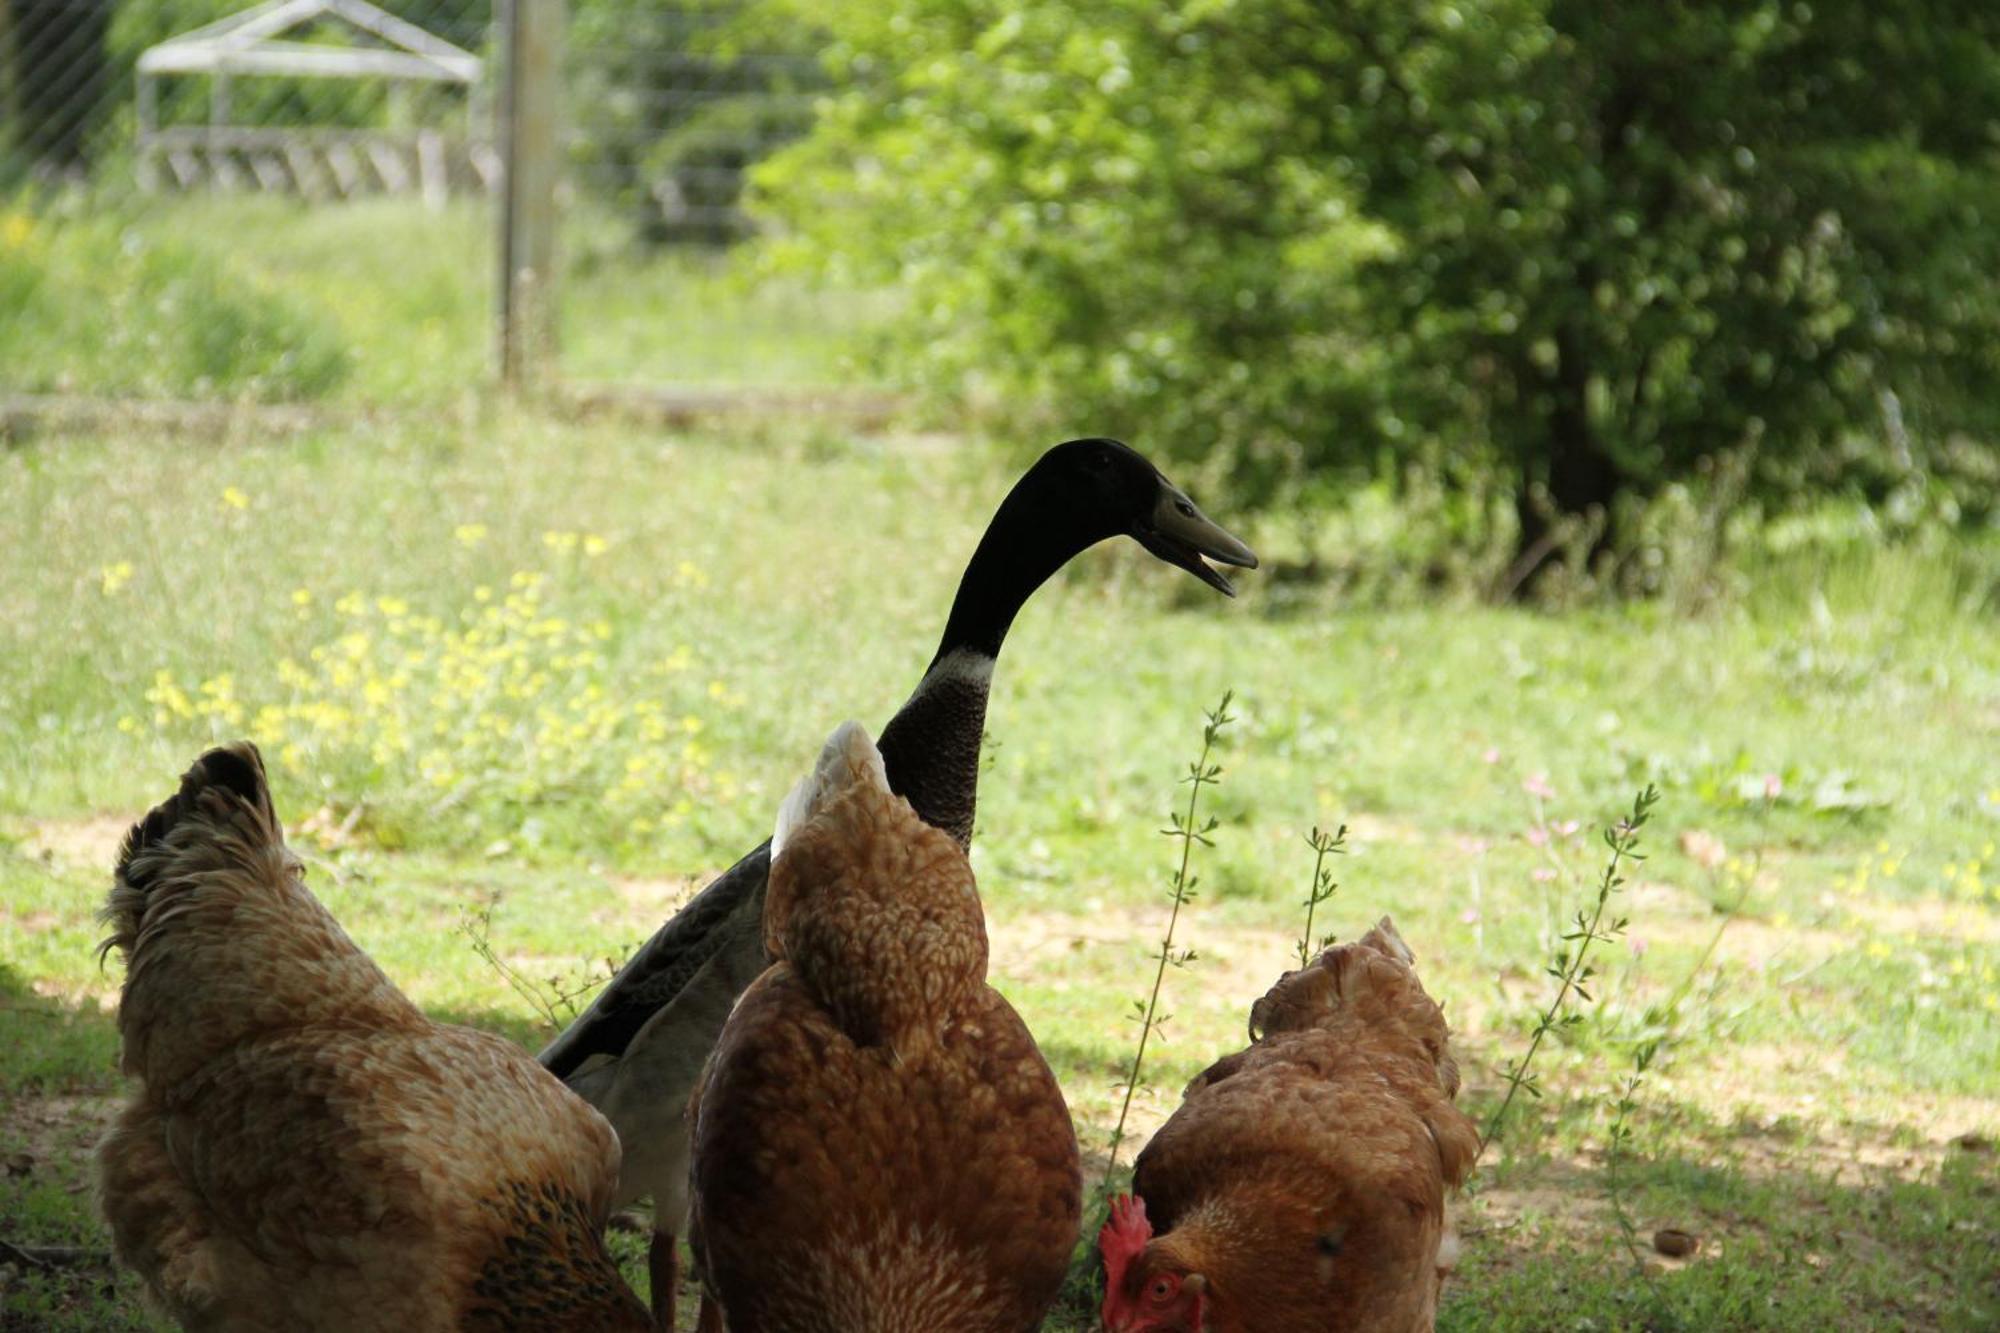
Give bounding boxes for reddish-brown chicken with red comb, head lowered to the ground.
[1098,917,1478,1333]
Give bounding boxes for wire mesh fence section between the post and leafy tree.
[560,0,878,390]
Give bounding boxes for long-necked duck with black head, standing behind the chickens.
[538,436,1256,1331]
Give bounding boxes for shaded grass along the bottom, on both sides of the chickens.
[0,963,2000,1333]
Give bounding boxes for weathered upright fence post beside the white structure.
[498,0,566,388]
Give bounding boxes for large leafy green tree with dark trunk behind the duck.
[758,0,2000,548]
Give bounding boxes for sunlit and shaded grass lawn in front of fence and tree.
[0,416,2000,1331]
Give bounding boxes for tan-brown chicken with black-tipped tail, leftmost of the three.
[98,743,648,1333]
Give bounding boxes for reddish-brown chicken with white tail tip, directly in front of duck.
[690,723,1082,1333]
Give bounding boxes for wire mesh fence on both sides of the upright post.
[0,0,868,402]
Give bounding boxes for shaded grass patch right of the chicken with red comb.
[1438,1099,2000,1333]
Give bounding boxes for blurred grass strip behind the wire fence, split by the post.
[0,194,880,404]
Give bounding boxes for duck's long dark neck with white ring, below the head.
[878,482,1110,847]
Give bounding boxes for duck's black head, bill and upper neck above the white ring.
[934,438,1256,660]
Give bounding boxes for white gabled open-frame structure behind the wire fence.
[138,0,500,206]
